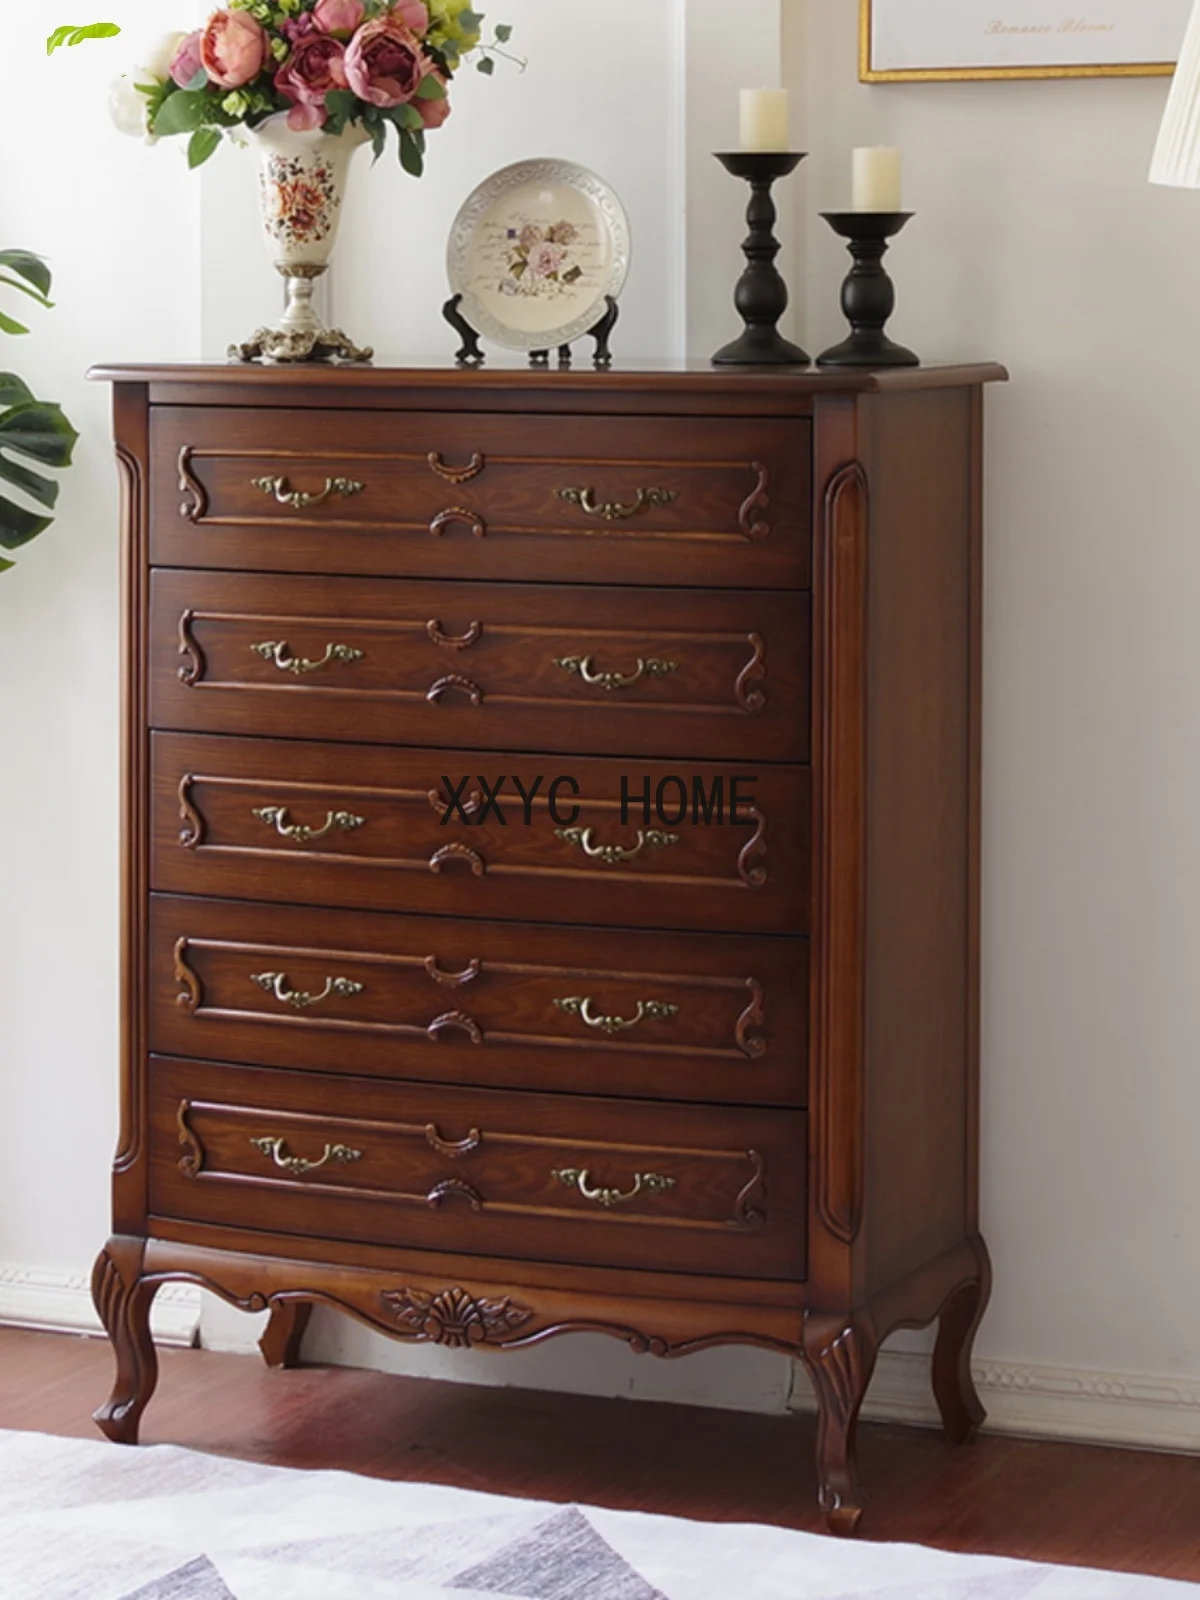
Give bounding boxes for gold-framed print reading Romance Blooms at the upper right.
[859,0,1192,83]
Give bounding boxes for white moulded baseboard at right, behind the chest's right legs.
[792,1350,1200,1453]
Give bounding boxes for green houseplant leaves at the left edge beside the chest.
[0,250,78,573]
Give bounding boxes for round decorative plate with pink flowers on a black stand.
[446,160,629,350]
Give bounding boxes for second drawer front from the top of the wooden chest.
[150,571,810,762]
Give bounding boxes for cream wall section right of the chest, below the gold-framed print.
[787,0,1200,1401]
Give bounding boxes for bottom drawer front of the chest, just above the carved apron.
[150,1058,806,1278]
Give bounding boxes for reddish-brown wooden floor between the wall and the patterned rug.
[0,1328,1200,1582]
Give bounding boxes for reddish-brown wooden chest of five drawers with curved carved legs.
[94,356,1003,1531]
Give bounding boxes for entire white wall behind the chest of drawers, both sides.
[0,0,1200,1442]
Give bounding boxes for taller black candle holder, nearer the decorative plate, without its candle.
[712,150,810,366]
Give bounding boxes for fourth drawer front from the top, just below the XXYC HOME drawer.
[149,896,808,1106]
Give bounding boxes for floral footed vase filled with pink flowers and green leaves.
[91,0,523,362]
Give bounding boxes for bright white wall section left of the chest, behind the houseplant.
[0,0,200,1272]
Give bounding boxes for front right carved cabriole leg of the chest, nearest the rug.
[803,1312,878,1534]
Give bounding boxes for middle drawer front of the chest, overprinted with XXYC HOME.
[150,733,811,933]
